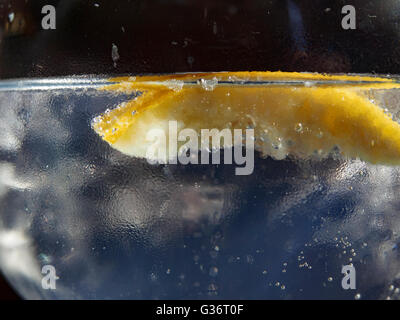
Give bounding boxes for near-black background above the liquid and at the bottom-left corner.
[0,0,400,299]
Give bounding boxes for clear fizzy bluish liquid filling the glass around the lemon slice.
[0,75,400,299]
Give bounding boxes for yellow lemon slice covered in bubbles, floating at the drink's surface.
[92,72,400,165]
